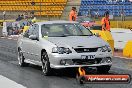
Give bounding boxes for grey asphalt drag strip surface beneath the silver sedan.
[0,39,132,88]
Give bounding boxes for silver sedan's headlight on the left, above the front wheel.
[52,47,72,54]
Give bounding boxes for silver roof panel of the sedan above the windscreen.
[35,20,78,25]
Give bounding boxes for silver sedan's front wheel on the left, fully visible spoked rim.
[41,52,51,76]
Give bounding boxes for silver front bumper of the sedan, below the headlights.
[49,52,112,69]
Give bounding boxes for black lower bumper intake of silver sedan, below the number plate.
[72,58,102,65]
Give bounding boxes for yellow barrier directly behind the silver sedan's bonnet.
[91,30,114,53]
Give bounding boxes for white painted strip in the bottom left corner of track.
[0,75,26,88]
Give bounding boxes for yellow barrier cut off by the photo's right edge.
[123,40,132,58]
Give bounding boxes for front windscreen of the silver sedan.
[41,23,93,37]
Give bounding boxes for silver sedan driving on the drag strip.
[18,21,112,75]
